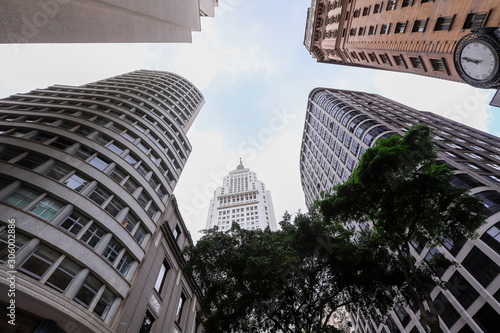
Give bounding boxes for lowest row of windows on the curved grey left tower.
[0,228,116,320]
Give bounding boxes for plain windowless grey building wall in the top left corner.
[0,0,219,43]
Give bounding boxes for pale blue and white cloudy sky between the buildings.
[0,0,500,240]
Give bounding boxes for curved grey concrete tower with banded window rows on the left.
[0,70,204,332]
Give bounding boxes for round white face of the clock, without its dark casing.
[460,40,499,81]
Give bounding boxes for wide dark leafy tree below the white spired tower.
[185,212,394,333]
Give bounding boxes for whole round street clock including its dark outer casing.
[454,33,500,88]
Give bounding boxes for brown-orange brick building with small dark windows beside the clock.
[304,0,500,87]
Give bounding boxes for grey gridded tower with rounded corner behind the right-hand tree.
[300,88,500,333]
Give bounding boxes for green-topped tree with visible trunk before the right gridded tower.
[319,126,485,332]
